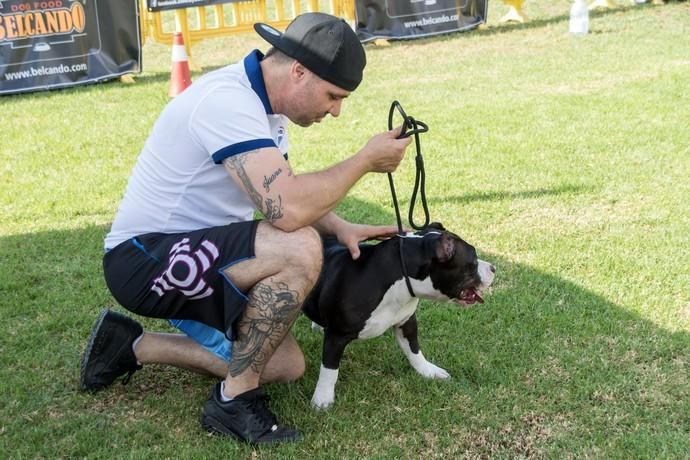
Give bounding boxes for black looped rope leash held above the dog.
[388,101,429,297]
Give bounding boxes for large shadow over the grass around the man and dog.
[0,197,690,458]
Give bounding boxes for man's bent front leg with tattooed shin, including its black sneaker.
[194,222,323,444]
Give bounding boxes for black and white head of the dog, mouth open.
[406,222,496,306]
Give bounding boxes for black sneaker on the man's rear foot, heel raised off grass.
[80,309,144,391]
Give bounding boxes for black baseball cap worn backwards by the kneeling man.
[254,13,367,91]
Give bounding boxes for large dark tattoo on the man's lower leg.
[228,282,301,377]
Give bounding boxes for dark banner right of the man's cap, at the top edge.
[355,0,488,42]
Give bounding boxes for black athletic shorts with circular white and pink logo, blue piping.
[103,221,259,340]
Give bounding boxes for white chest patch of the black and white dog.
[358,280,419,339]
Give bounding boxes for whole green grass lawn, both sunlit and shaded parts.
[0,0,690,459]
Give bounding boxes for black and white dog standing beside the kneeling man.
[302,223,496,409]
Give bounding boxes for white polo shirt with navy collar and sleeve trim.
[105,50,288,250]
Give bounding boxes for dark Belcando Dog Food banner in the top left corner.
[0,0,141,94]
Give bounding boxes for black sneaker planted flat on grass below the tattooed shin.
[201,383,302,444]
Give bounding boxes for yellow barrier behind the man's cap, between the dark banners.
[140,0,355,62]
